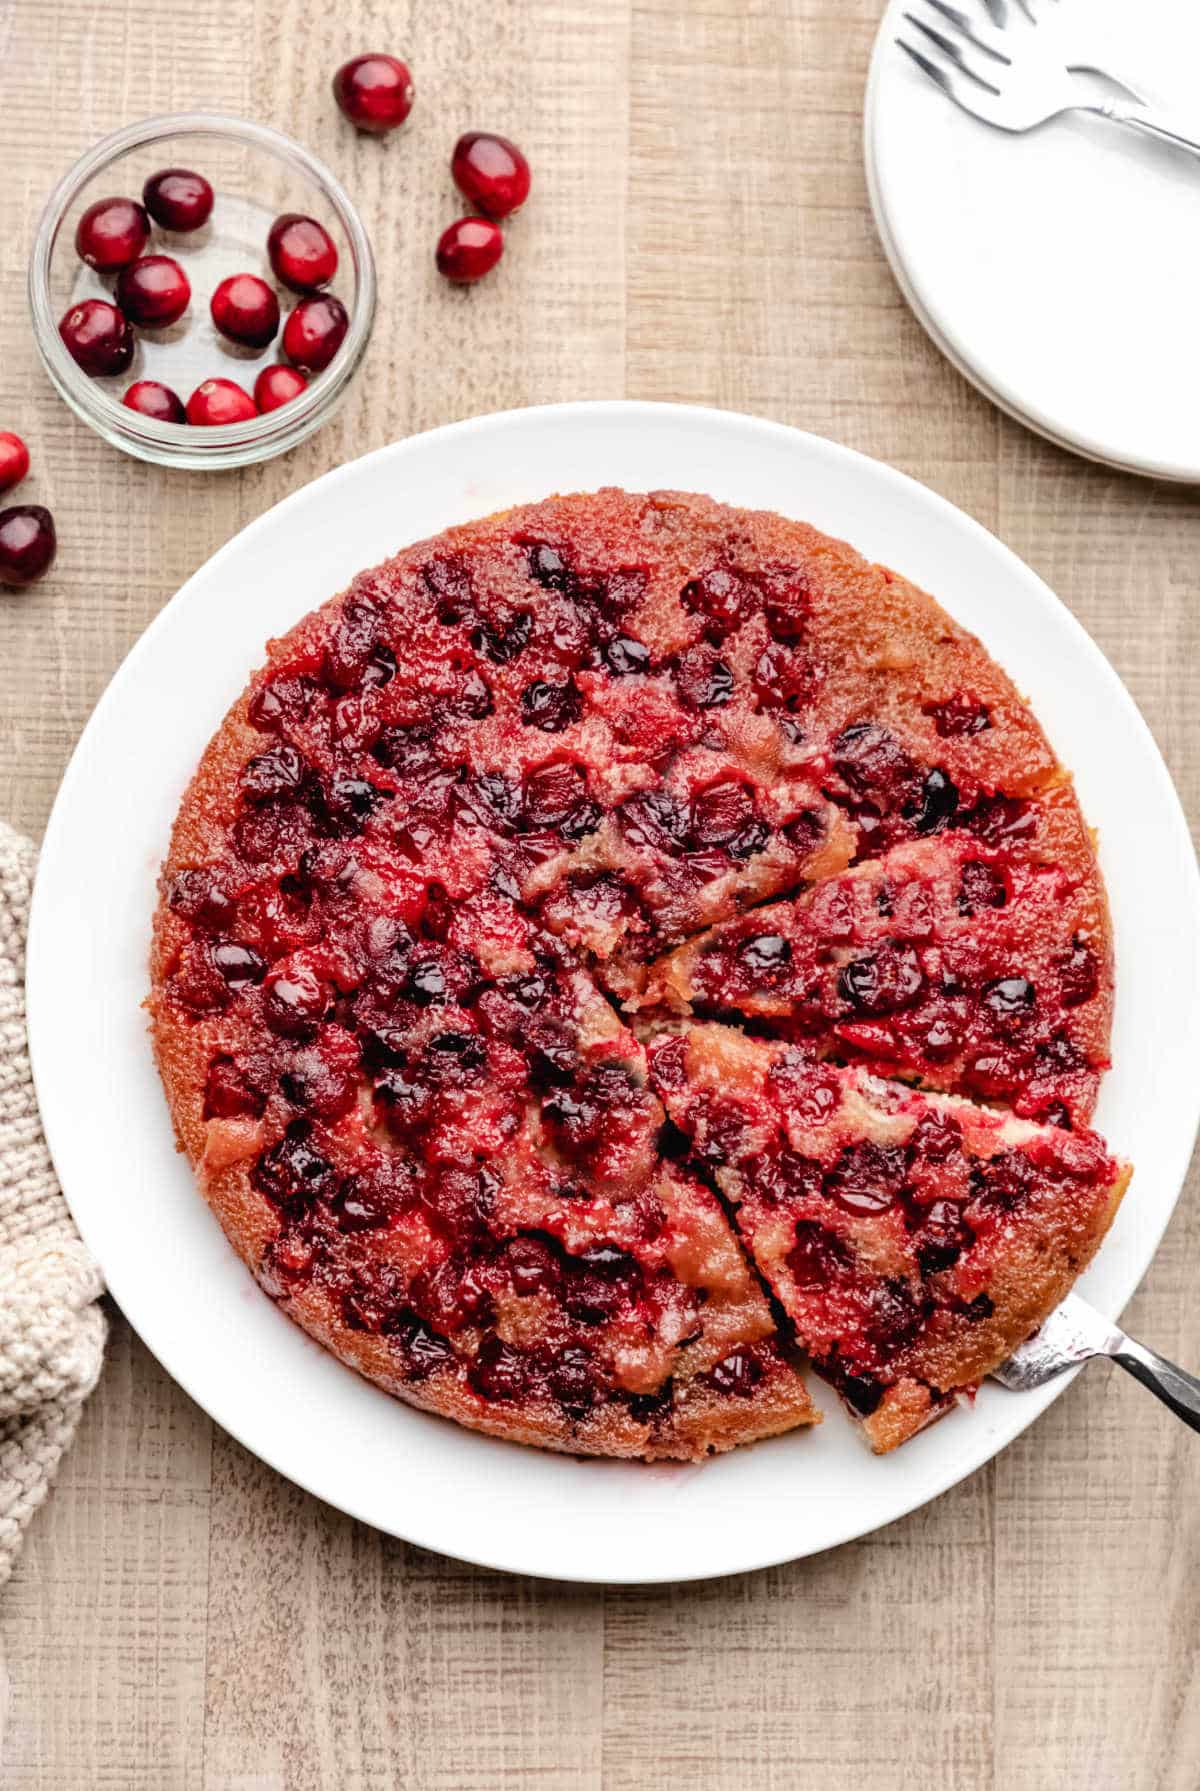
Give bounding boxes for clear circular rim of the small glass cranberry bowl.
[27,111,376,467]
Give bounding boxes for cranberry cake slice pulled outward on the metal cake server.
[650,1024,1130,1451]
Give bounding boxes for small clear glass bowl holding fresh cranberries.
[29,113,376,469]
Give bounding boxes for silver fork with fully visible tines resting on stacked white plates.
[896,0,1200,156]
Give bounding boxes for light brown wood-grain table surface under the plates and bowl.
[0,0,1200,1791]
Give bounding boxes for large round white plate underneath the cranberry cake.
[29,403,1200,1581]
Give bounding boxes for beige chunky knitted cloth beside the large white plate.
[0,822,106,1585]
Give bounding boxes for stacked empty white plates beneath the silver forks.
[865,0,1200,482]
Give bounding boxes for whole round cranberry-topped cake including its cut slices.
[149,491,1128,1460]
